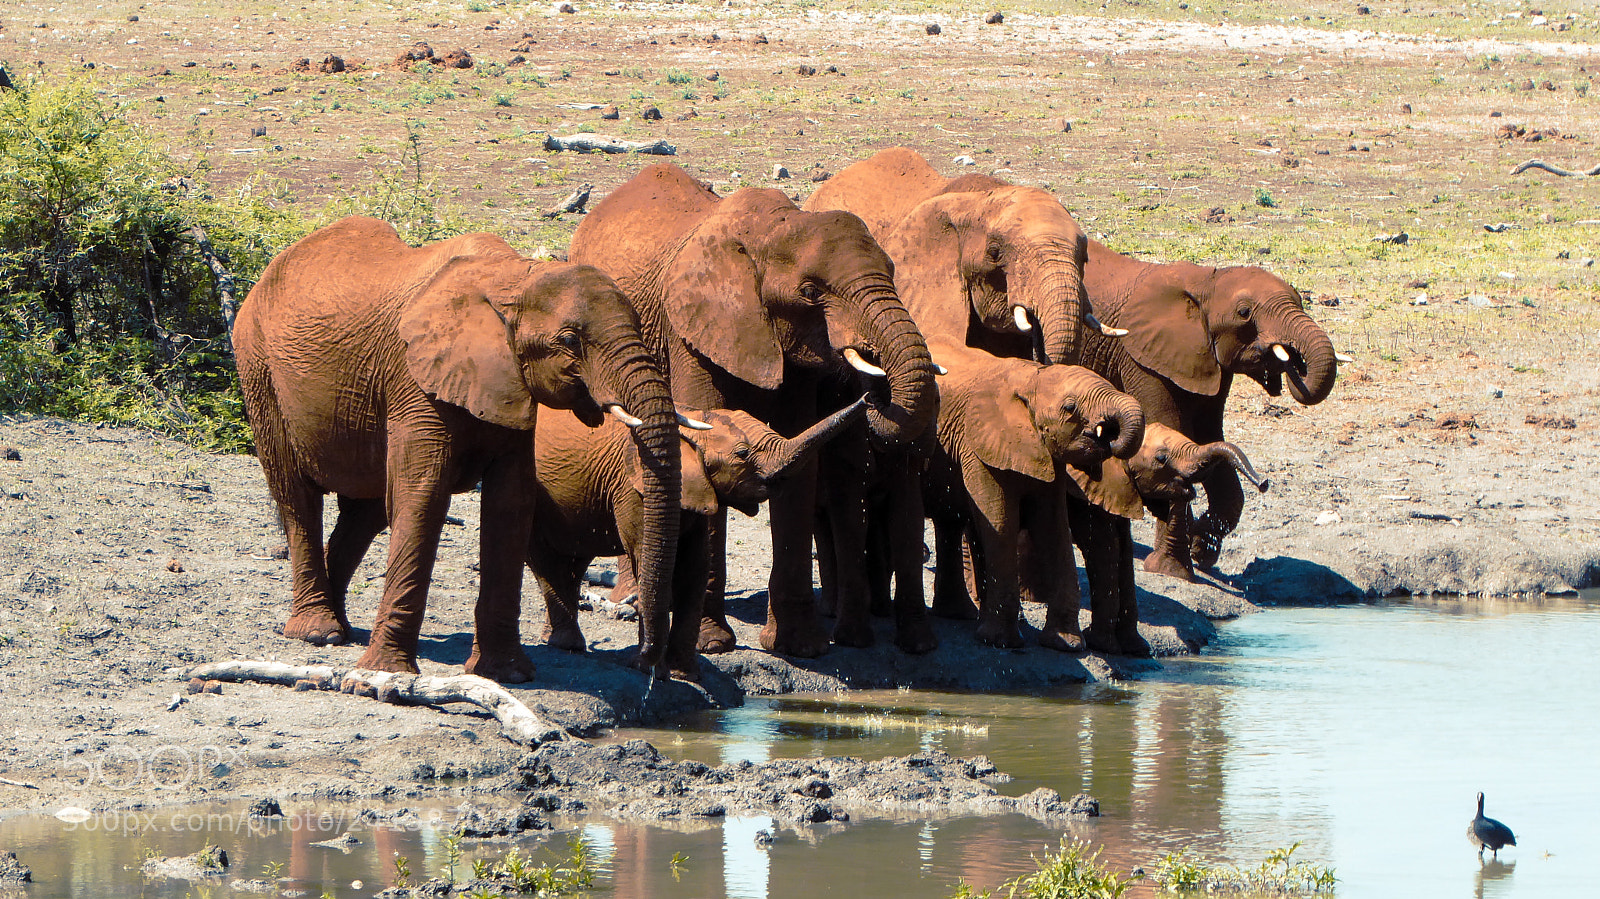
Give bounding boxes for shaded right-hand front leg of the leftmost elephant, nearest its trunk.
[464,447,534,683]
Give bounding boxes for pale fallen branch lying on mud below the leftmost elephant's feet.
[166,659,566,745]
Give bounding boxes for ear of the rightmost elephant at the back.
[1106,266,1222,397]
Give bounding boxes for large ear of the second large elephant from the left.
[664,213,784,390]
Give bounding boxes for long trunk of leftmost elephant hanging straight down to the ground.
[602,338,683,672]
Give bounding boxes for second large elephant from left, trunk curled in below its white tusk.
[570,165,936,656]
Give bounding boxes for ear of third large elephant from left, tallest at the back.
[882,194,978,342]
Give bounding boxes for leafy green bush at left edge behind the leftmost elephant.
[0,75,467,451]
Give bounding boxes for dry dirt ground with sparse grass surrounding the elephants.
[0,0,1600,809]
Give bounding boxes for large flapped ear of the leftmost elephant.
[398,265,538,430]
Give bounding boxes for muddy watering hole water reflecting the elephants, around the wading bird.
[0,592,1600,899]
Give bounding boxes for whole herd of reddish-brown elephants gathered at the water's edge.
[234,149,1338,683]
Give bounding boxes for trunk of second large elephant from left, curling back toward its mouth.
[846,277,938,446]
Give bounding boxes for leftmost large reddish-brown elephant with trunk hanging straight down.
[234,218,680,681]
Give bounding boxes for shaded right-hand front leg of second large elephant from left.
[760,461,827,659]
